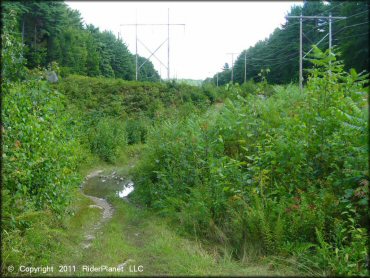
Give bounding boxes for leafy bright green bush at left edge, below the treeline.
[2,81,84,227]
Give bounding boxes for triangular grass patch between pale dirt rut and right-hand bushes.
[52,196,296,276]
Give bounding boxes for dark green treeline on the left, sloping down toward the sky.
[2,1,160,81]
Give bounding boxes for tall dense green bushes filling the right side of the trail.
[133,48,368,275]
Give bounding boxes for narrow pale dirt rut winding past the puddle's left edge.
[81,170,114,249]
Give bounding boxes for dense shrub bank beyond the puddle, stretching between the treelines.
[54,75,216,155]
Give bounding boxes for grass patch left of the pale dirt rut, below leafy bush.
[2,190,101,276]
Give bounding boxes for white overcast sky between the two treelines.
[66,1,303,79]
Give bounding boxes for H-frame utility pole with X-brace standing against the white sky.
[120,9,185,80]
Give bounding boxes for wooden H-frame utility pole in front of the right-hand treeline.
[285,13,347,90]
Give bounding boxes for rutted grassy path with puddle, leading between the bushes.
[71,164,296,276]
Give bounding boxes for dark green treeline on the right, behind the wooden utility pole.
[210,1,369,85]
